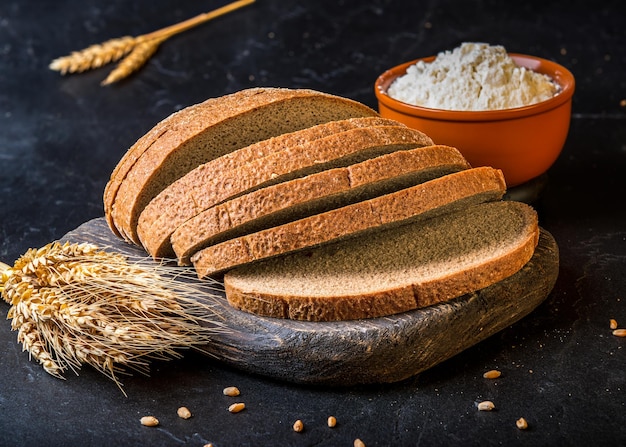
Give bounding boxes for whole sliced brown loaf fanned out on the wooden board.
[104,89,538,321]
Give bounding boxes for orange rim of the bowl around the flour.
[374,53,575,121]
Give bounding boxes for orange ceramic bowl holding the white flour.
[375,54,574,187]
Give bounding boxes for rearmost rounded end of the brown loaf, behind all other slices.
[104,88,378,243]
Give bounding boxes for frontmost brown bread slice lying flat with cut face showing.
[224,201,539,321]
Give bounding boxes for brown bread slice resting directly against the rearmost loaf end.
[137,125,433,257]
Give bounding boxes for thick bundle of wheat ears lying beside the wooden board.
[0,242,224,392]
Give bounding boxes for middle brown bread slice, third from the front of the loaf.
[171,145,470,265]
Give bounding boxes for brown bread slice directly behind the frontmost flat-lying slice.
[191,167,506,278]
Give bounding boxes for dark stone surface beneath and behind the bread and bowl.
[0,0,626,447]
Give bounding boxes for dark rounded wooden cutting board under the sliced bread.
[62,218,559,385]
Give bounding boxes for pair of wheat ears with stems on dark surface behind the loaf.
[49,0,255,85]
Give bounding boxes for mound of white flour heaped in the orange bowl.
[387,42,559,110]
